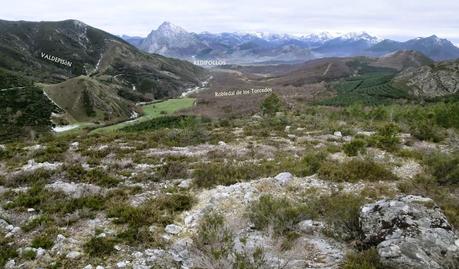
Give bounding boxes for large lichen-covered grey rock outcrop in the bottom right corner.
[360,195,459,269]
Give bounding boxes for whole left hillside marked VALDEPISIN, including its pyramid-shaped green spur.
[0,20,207,137]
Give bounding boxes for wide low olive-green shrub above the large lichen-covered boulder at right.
[318,159,397,182]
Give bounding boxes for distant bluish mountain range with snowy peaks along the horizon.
[123,22,459,64]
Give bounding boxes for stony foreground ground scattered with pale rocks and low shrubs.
[0,109,459,269]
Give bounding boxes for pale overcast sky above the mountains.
[0,0,459,44]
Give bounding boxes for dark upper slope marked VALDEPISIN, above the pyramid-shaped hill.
[0,20,207,90]
